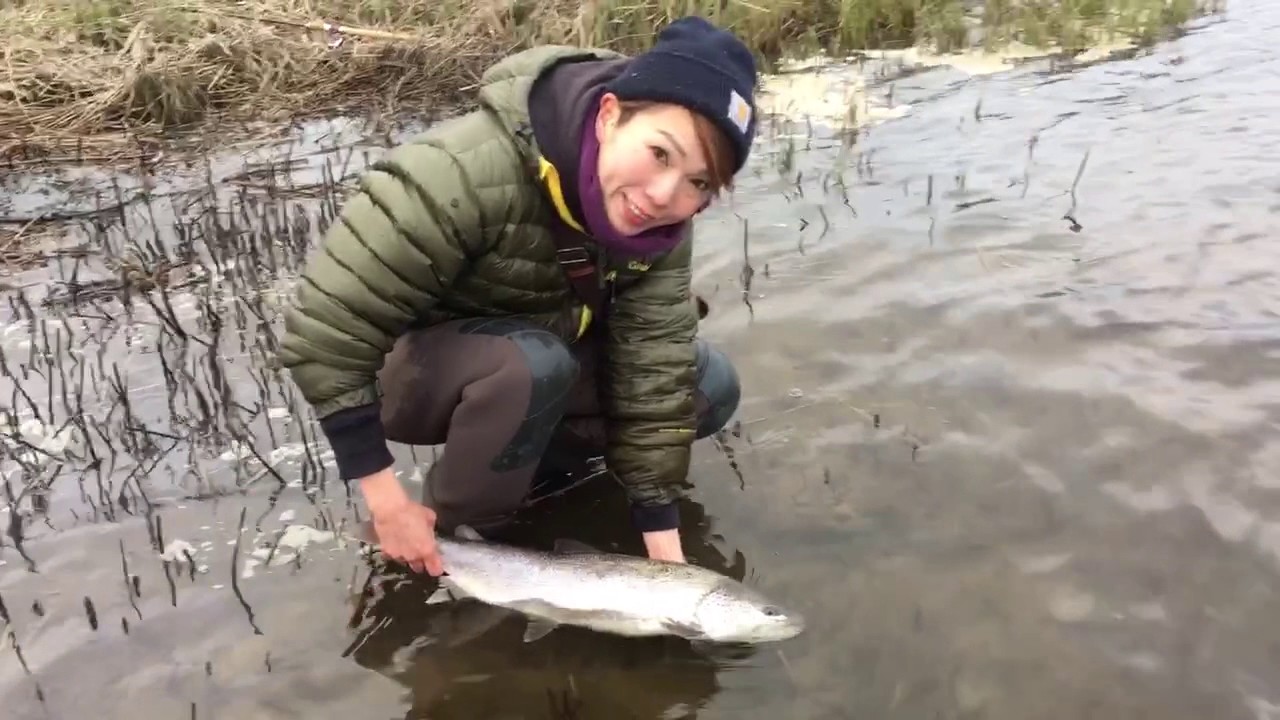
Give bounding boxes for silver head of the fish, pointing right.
[694,582,805,643]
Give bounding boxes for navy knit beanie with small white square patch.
[605,15,755,173]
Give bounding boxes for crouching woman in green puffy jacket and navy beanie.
[282,17,755,575]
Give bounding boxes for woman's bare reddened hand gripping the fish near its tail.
[360,468,444,575]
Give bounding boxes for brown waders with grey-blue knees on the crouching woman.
[379,318,740,529]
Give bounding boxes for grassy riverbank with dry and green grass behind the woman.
[0,0,1221,163]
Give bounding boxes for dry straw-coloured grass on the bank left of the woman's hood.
[0,0,509,158]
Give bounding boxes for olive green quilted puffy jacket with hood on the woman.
[282,46,698,506]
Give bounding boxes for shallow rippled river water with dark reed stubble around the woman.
[0,0,1280,720]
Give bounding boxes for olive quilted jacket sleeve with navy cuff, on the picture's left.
[280,138,483,479]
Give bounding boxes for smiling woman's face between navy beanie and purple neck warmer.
[595,94,712,236]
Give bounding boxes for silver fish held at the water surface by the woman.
[356,521,805,643]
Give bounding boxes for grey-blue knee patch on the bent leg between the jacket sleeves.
[458,318,579,473]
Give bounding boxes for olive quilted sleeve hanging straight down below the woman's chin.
[602,226,698,532]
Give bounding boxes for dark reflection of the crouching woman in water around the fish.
[348,478,755,719]
